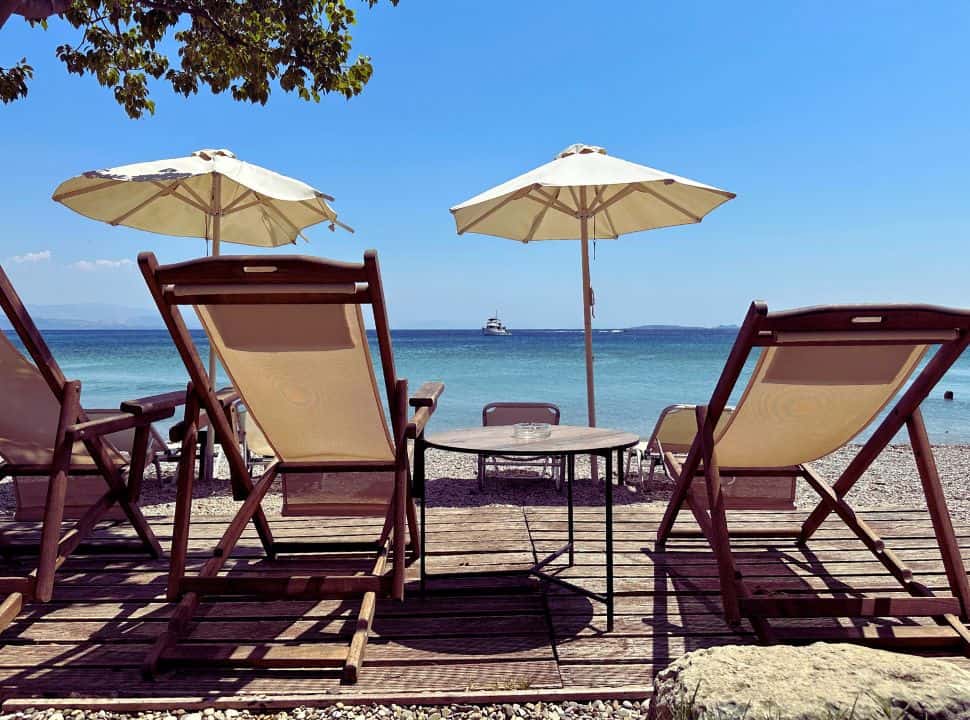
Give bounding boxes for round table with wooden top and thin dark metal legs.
[414,425,640,632]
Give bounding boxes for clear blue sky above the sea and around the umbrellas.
[0,0,970,328]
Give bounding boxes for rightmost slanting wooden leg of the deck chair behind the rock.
[906,409,970,619]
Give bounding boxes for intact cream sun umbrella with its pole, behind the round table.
[451,145,734,436]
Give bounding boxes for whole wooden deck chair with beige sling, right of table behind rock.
[657,303,970,649]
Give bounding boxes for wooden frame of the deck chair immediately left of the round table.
[138,250,444,682]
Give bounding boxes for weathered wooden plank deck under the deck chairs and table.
[0,507,970,711]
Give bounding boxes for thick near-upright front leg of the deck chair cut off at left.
[34,381,81,602]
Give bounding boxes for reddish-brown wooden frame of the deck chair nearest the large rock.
[657,302,970,651]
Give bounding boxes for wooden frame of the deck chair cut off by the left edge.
[0,267,168,630]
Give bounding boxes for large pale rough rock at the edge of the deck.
[651,643,970,720]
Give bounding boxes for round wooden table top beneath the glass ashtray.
[425,425,640,455]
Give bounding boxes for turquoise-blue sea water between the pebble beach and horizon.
[7,329,970,443]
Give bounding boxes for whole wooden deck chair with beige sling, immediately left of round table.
[138,251,443,682]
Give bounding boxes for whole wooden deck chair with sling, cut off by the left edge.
[0,267,168,629]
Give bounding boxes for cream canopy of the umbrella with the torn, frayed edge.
[53,150,350,254]
